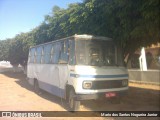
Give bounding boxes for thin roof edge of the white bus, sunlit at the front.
[30,34,112,48]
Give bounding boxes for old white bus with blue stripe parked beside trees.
[27,34,128,110]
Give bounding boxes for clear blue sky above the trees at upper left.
[0,0,82,40]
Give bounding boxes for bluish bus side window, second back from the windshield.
[59,40,69,64]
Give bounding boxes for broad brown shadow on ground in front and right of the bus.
[82,87,160,111]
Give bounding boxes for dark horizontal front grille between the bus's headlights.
[90,80,128,90]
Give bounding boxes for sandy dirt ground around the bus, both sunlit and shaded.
[0,72,160,120]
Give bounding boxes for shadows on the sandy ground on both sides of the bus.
[3,72,160,111]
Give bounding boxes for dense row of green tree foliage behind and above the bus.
[0,0,160,64]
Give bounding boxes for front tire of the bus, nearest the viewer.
[69,89,80,111]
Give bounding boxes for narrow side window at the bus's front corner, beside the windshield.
[69,40,76,65]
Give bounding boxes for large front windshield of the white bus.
[76,40,122,66]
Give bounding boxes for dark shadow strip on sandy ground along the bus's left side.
[2,72,69,110]
